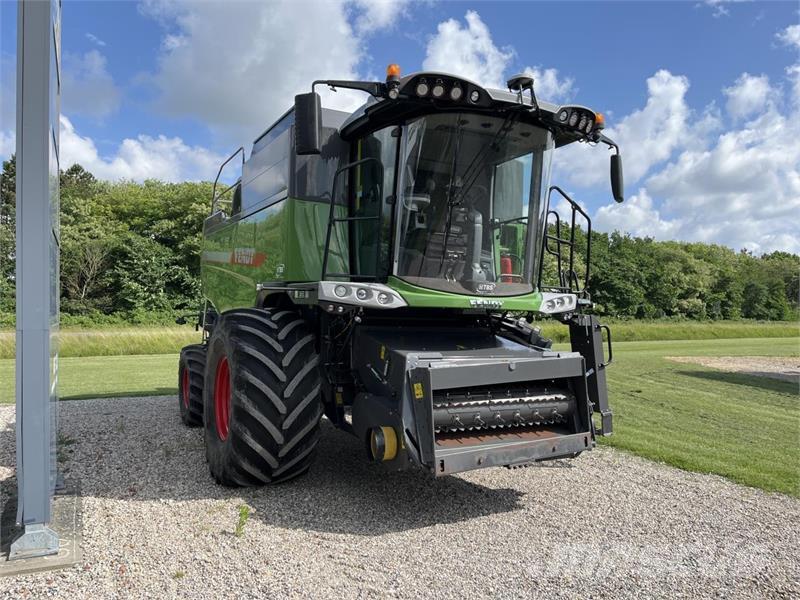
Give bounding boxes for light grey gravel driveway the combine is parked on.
[0,397,800,599]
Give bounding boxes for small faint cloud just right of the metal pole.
[61,50,121,118]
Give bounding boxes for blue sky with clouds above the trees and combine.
[0,0,800,252]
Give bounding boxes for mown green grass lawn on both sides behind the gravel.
[0,338,800,496]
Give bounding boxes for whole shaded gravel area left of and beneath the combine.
[0,410,523,536]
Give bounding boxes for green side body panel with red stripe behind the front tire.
[200,198,349,312]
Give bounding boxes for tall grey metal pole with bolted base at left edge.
[9,0,61,559]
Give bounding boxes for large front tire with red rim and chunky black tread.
[203,309,322,486]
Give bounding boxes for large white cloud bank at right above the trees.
[556,20,800,252]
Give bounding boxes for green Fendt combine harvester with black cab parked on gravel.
[179,65,622,486]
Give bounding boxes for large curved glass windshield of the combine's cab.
[395,113,553,296]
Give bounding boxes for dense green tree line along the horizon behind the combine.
[0,157,800,324]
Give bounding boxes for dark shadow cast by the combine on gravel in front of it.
[242,422,522,535]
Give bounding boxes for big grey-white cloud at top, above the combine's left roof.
[141,0,405,143]
